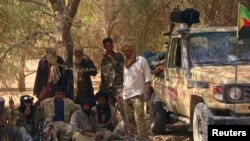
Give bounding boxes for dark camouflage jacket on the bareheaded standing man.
[100,53,124,92]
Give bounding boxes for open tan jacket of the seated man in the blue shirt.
[40,98,81,125]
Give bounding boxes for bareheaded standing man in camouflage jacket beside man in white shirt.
[100,38,124,106]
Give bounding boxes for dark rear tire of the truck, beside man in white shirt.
[150,101,170,134]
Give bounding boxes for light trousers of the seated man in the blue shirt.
[52,121,73,141]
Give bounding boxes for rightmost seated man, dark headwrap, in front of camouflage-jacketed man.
[92,91,123,133]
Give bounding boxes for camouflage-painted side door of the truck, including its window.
[164,37,186,115]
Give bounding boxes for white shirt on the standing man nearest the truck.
[123,56,152,100]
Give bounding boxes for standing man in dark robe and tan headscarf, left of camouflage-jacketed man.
[73,47,97,107]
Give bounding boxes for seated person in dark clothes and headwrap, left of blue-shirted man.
[15,95,39,140]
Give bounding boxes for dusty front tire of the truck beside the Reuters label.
[193,103,211,141]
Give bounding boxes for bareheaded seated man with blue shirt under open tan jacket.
[40,88,80,141]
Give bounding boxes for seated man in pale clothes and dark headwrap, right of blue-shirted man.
[70,99,105,141]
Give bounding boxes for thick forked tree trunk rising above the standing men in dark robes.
[50,0,80,64]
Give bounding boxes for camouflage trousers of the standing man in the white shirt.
[124,95,147,136]
